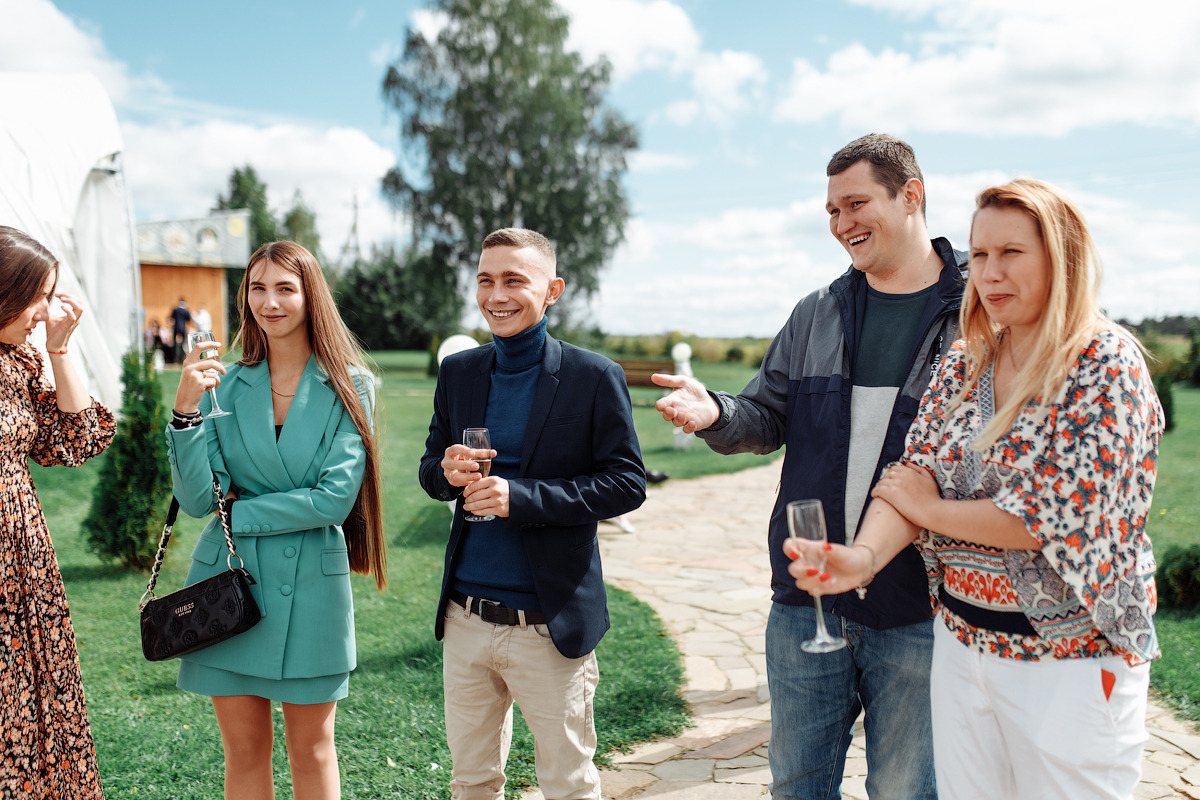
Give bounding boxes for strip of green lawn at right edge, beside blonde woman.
[1146,384,1200,720]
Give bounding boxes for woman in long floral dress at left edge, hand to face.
[0,225,116,800]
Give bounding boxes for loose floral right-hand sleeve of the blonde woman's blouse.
[994,332,1163,658]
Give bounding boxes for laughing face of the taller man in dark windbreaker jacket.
[826,161,924,275]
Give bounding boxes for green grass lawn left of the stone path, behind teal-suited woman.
[42,353,761,800]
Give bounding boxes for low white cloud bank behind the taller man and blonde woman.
[594,172,1200,337]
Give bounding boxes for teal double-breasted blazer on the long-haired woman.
[167,356,374,680]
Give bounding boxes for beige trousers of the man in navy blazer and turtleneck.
[442,602,600,800]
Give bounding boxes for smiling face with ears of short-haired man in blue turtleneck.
[475,246,565,338]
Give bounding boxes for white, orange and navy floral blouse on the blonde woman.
[904,330,1163,664]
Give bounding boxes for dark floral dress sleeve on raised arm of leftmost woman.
[23,345,116,467]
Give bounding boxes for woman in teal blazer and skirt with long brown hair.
[167,241,386,800]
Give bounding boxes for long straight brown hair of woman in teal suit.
[234,241,388,590]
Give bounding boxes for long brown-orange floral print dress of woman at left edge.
[0,344,116,800]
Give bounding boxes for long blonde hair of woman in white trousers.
[943,178,1117,451]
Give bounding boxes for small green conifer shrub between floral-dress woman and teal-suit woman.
[83,350,170,570]
